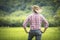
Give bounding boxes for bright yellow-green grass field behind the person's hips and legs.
[0,27,60,40]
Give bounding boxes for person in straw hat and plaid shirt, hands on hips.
[23,5,48,40]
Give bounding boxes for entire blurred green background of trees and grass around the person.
[0,0,60,40]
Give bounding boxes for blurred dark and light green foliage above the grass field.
[0,0,60,27]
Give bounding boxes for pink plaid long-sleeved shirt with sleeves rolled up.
[23,13,48,30]
